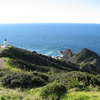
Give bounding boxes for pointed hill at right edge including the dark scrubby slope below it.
[70,48,100,74]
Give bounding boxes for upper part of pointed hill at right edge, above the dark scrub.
[70,48,100,66]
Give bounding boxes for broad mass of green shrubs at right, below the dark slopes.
[49,71,100,90]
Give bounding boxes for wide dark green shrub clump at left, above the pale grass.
[1,72,46,88]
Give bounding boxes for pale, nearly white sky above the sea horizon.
[0,0,100,24]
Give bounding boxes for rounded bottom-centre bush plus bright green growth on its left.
[29,83,66,100]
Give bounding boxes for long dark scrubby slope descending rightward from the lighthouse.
[0,46,79,72]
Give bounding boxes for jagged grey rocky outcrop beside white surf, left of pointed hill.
[59,49,74,60]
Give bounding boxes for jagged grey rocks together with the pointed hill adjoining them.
[59,48,100,67]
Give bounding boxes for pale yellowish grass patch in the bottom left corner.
[0,87,39,100]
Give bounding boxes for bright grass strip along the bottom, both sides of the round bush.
[0,87,100,100]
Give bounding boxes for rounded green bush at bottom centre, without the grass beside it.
[39,83,66,100]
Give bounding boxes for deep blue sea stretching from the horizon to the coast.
[0,23,100,56]
